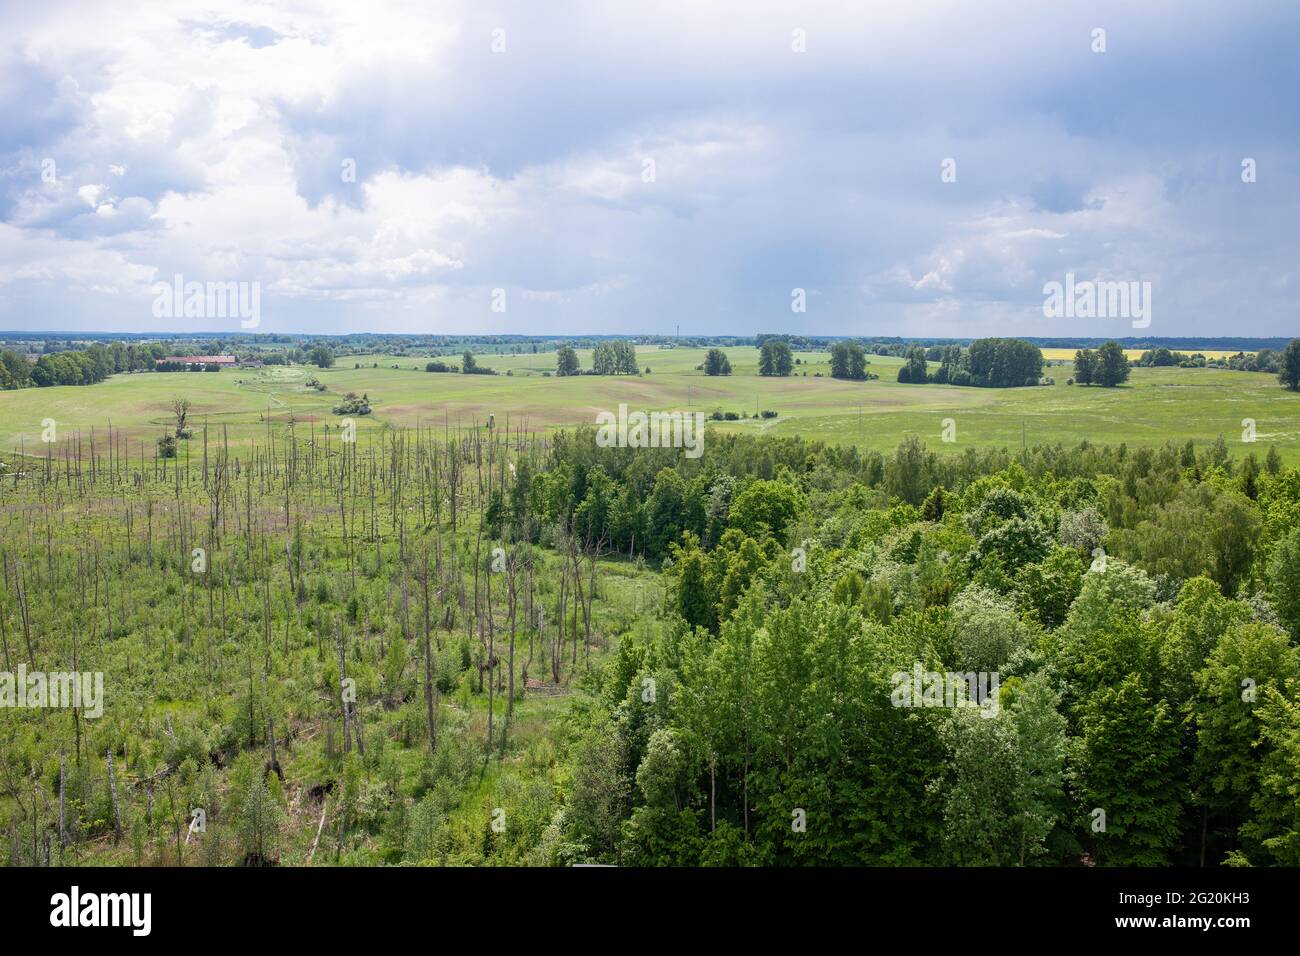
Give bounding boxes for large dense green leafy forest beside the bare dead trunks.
[556,436,1300,865]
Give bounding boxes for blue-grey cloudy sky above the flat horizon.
[0,0,1300,336]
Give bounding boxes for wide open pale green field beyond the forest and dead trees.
[0,347,1300,463]
